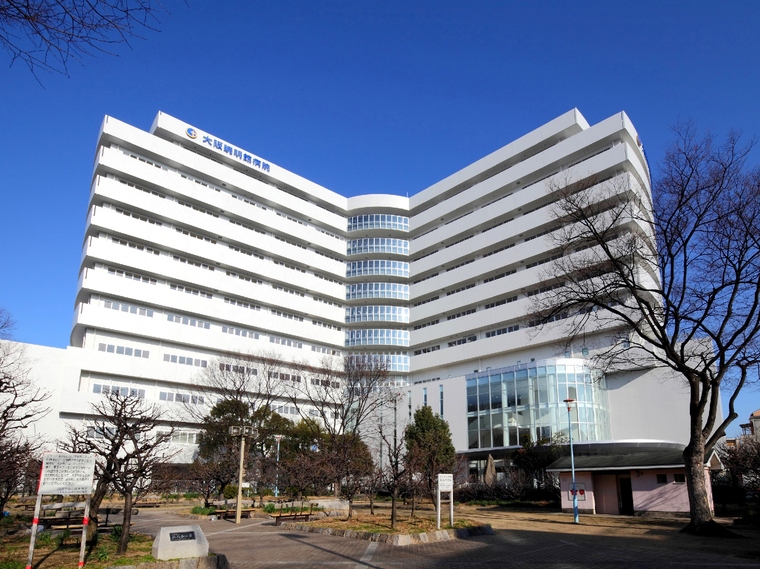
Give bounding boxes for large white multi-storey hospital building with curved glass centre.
[14,110,688,466]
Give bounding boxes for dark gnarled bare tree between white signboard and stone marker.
[61,391,174,553]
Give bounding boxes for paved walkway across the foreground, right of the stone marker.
[126,510,760,569]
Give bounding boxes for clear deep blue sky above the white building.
[0,0,760,432]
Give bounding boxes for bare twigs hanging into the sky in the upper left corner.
[0,0,163,74]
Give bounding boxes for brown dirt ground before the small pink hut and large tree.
[454,505,760,560]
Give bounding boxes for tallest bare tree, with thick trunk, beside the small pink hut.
[530,124,760,533]
